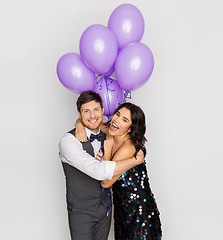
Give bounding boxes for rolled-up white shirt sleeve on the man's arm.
[59,133,116,180]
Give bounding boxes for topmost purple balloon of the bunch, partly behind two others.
[108,3,145,49]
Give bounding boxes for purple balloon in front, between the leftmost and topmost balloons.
[79,24,118,74]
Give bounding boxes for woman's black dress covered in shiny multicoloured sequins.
[112,163,162,240]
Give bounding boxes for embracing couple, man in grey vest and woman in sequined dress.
[59,91,162,240]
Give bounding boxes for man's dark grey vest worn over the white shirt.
[62,129,111,211]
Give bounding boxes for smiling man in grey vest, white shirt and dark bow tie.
[59,91,144,240]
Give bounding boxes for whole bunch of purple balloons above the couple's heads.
[57,4,154,116]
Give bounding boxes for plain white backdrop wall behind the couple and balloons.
[0,0,223,240]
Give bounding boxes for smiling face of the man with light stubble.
[78,100,104,133]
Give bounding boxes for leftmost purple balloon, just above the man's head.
[57,53,95,93]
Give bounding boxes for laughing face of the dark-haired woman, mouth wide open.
[109,107,132,136]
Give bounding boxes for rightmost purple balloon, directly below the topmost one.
[115,42,154,92]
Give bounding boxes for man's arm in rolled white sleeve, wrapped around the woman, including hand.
[59,133,144,180]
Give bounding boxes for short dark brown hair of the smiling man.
[76,91,103,112]
